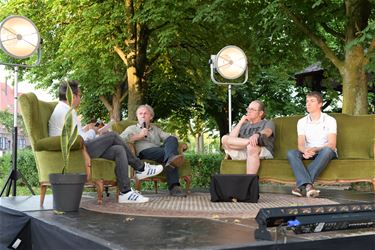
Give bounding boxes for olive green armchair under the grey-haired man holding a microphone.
[112,120,191,193]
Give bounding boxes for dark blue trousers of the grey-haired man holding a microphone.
[139,136,180,189]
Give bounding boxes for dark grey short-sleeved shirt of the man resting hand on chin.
[238,119,275,154]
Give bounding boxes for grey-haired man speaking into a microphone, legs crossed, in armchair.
[120,104,186,197]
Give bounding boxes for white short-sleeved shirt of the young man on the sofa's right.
[297,113,337,148]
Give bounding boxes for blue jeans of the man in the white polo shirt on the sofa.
[288,147,336,188]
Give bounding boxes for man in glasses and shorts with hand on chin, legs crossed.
[221,100,275,174]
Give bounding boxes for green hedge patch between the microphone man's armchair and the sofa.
[185,154,224,188]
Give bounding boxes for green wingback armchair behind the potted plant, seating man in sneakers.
[19,93,118,206]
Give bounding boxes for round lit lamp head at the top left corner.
[0,16,40,59]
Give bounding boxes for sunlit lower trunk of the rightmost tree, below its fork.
[341,46,368,115]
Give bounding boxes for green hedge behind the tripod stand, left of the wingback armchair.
[0,148,39,187]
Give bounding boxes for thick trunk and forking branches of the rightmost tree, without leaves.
[280,0,371,115]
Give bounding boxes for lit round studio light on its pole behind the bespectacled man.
[210,45,248,132]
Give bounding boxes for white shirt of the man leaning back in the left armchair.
[48,101,96,141]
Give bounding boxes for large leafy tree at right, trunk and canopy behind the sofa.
[197,0,375,114]
